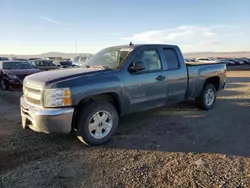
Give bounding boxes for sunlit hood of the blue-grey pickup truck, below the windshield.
[24,68,105,89]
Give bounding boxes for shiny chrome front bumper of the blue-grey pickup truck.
[20,96,74,134]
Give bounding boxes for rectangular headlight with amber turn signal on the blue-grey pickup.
[43,88,72,107]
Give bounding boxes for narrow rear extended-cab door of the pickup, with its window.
[159,46,188,104]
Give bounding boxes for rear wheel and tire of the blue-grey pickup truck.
[196,84,217,110]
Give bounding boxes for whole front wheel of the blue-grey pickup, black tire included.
[77,101,119,146]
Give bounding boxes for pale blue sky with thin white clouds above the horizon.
[0,0,250,55]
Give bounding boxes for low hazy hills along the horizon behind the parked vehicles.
[0,51,250,58]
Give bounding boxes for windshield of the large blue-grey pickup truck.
[85,48,133,70]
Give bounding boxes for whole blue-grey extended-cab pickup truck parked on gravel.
[20,44,226,145]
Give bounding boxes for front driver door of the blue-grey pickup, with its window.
[125,47,166,113]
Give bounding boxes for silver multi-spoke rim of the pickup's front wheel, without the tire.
[89,110,113,139]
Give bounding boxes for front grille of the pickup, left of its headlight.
[23,85,42,106]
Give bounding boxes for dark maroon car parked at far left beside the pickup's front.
[0,60,39,90]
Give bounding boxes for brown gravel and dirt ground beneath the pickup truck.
[0,66,250,188]
